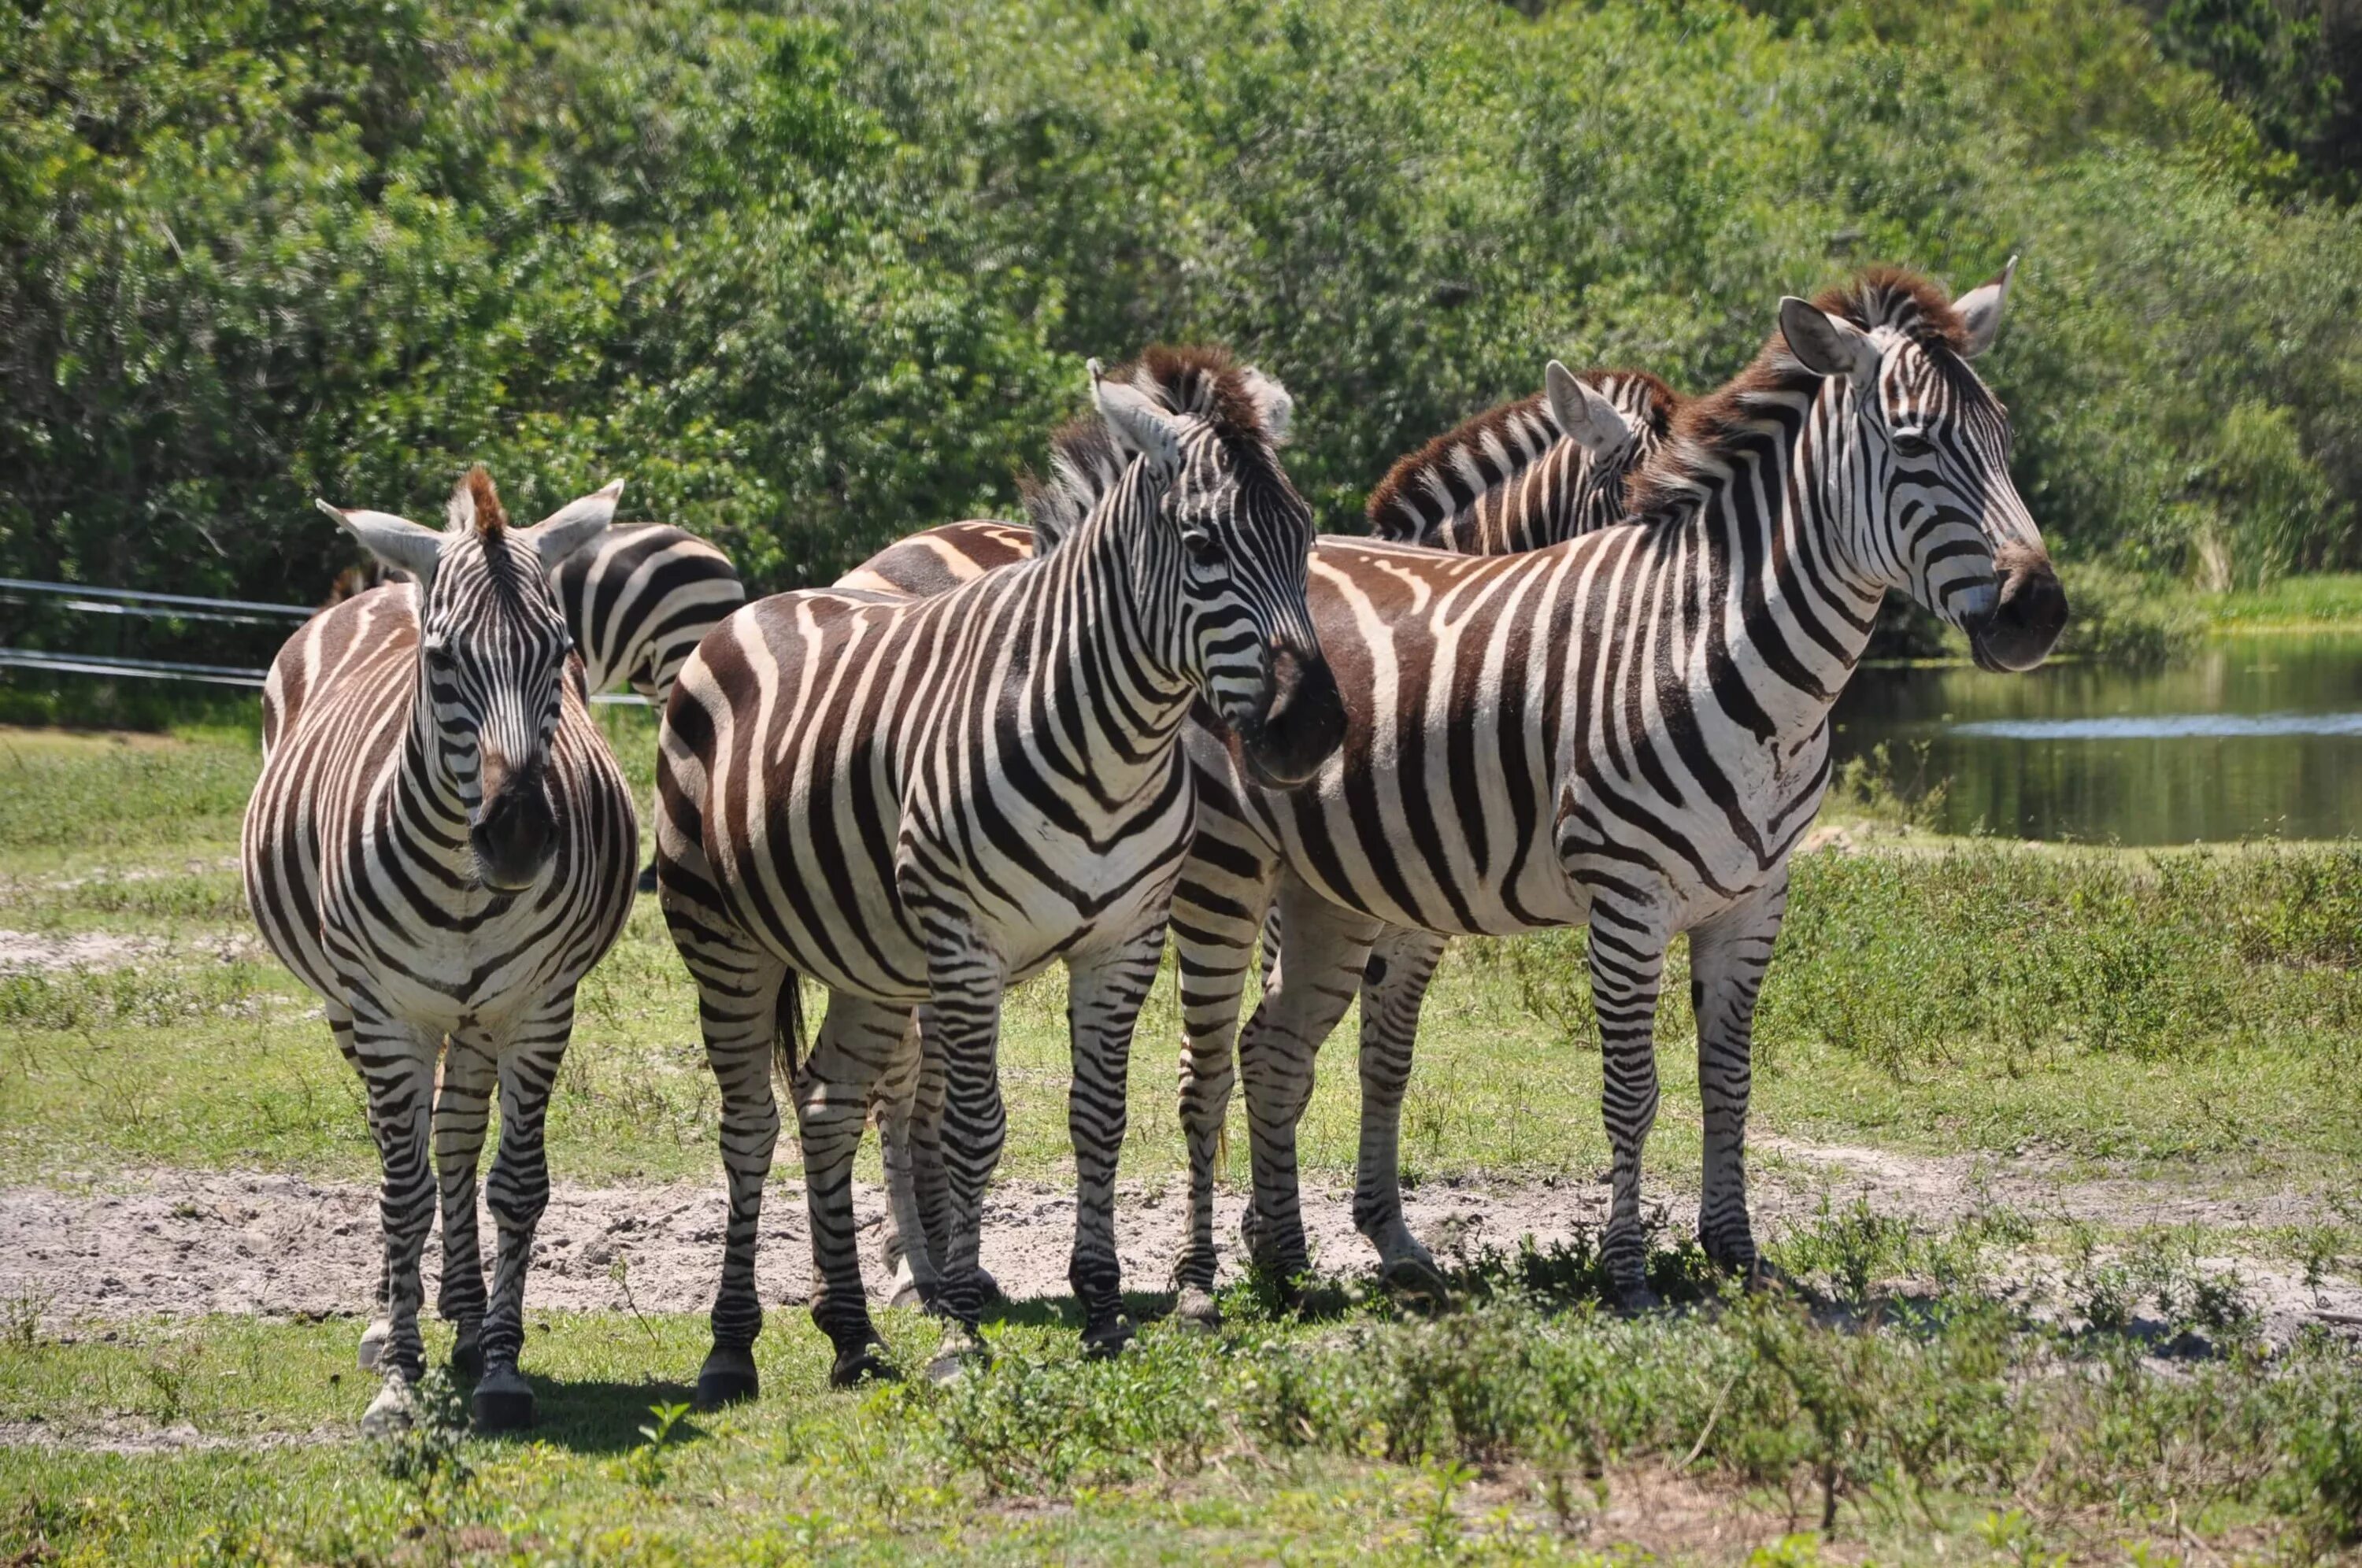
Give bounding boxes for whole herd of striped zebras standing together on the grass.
[243,269,2067,1431]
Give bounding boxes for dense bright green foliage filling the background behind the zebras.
[0,0,2362,647]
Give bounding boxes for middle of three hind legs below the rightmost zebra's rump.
[1238,878,1384,1280]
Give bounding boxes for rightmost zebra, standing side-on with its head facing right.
[1172,269,2067,1306]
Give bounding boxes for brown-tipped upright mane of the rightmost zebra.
[1625,267,1975,520]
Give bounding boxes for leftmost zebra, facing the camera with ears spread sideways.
[241,468,638,1433]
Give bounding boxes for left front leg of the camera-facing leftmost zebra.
[354,1008,442,1436]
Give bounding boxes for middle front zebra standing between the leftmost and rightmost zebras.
[657,349,1339,1405]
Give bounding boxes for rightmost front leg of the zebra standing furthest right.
[1689,862,1788,1282]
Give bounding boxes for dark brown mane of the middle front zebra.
[1018,345,1294,555]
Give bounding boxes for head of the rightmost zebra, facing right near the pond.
[1779,257,2067,671]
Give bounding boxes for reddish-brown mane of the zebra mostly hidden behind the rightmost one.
[1368,371,1679,543]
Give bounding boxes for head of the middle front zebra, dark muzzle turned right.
[1072,347,1344,789]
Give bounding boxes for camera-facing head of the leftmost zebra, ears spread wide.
[319,468,624,893]
